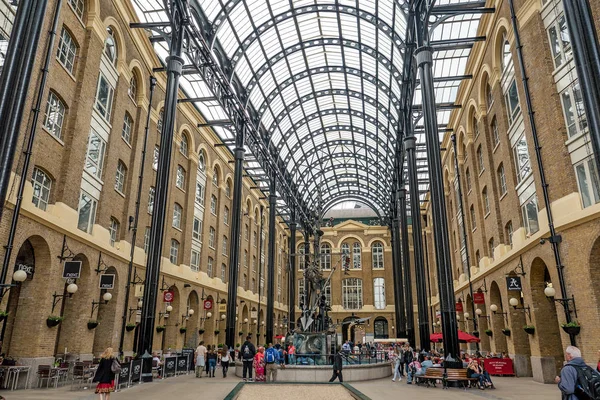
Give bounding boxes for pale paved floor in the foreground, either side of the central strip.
[0,375,560,400]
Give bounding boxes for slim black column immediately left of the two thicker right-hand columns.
[398,189,415,346]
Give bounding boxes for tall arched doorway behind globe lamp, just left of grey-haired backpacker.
[529,258,564,383]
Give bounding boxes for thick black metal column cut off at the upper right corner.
[561,0,600,172]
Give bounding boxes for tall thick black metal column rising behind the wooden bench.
[415,42,460,360]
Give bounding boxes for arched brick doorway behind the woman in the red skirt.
[90,267,121,356]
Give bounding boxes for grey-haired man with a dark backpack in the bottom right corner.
[554,346,600,400]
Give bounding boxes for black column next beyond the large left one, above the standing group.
[225,124,246,352]
